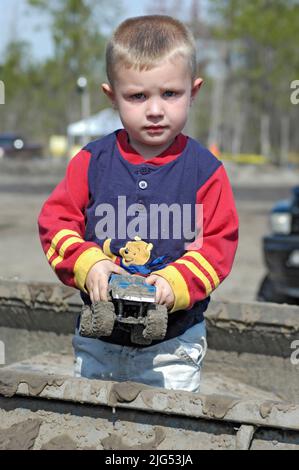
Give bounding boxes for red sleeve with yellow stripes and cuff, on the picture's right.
[155,165,238,312]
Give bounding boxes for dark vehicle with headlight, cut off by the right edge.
[257,186,299,304]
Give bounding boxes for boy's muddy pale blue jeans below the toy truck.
[73,321,207,392]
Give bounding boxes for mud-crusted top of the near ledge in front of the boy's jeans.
[0,369,299,431]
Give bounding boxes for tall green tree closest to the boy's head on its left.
[29,0,120,132]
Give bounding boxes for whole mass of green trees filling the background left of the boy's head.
[0,0,120,143]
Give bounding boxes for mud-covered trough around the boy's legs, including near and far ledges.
[0,283,299,450]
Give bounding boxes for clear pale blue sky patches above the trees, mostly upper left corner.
[0,0,149,62]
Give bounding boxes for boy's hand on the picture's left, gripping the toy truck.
[85,260,128,303]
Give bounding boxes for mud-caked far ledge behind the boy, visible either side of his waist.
[0,281,299,357]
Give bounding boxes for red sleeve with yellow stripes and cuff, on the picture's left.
[38,150,109,291]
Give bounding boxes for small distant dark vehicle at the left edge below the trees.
[0,134,42,158]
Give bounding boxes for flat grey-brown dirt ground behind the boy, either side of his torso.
[0,163,298,301]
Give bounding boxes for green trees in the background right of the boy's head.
[210,0,299,159]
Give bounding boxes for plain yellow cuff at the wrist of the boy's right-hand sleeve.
[152,266,190,313]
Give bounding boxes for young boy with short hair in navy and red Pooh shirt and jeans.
[39,16,238,392]
